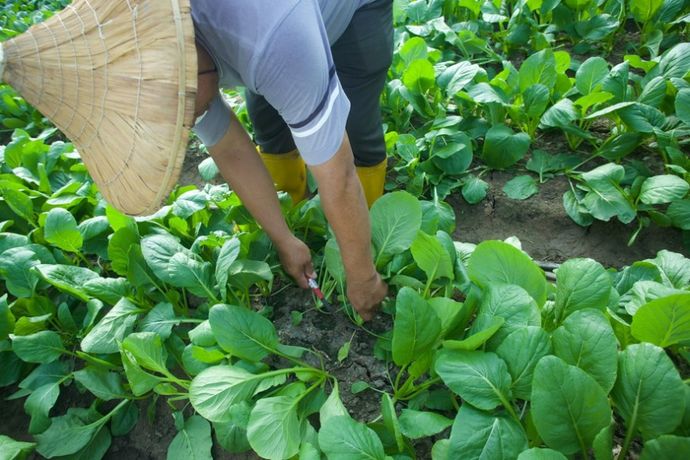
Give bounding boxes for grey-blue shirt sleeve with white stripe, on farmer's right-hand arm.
[253,1,350,165]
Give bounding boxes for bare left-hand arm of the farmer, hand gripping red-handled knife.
[204,109,315,288]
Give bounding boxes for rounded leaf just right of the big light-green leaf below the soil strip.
[554,259,612,323]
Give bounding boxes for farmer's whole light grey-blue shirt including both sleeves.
[191,0,373,165]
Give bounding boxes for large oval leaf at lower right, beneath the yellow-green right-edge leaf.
[611,343,685,439]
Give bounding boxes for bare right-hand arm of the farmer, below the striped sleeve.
[309,135,388,320]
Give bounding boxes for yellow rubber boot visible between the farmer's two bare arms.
[259,150,307,204]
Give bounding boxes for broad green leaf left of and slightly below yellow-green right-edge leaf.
[553,309,618,394]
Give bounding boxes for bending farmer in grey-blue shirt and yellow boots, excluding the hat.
[191,0,393,319]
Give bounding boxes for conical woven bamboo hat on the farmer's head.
[0,0,197,215]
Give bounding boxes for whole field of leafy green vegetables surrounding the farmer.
[0,0,690,460]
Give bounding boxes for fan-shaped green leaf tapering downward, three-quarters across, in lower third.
[496,326,552,400]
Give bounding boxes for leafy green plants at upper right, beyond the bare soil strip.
[383,0,690,243]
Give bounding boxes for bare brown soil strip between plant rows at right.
[448,172,688,268]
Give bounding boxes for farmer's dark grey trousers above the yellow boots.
[245,0,393,166]
